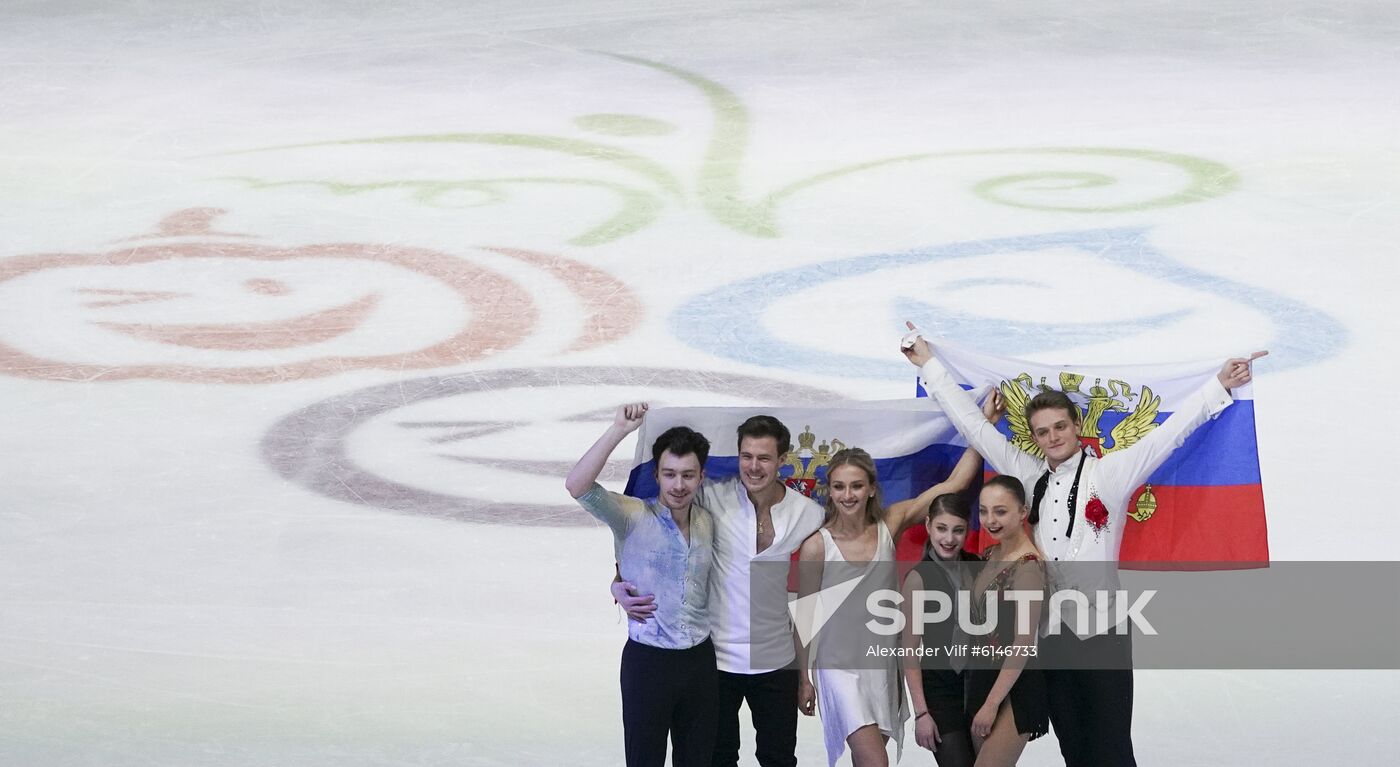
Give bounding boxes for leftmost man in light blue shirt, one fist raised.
[564,403,718,767]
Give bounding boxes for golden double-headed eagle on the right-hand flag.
[998,372,1162,522]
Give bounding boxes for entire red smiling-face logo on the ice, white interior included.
[0,209,640,384]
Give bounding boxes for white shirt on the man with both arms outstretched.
[921,358,1235,634]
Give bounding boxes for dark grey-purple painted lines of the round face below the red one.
[262,367,844,528]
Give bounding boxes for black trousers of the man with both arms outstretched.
[1040,631,1137,767]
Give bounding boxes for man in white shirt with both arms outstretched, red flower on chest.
[902,325,1267,767]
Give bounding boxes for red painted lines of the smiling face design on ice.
[0,209,641,384]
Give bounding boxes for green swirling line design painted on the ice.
[225,52,1239,246]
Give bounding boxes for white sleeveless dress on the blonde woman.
[812,522,909,766]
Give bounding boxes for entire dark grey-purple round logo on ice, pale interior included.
[263,367,841,526]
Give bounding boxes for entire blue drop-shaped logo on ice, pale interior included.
[671,228,1348,379]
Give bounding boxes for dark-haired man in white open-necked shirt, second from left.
[612,416,825,767]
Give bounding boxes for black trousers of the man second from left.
[711,669,798,767]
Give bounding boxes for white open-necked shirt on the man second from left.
[697,477,825,673]
